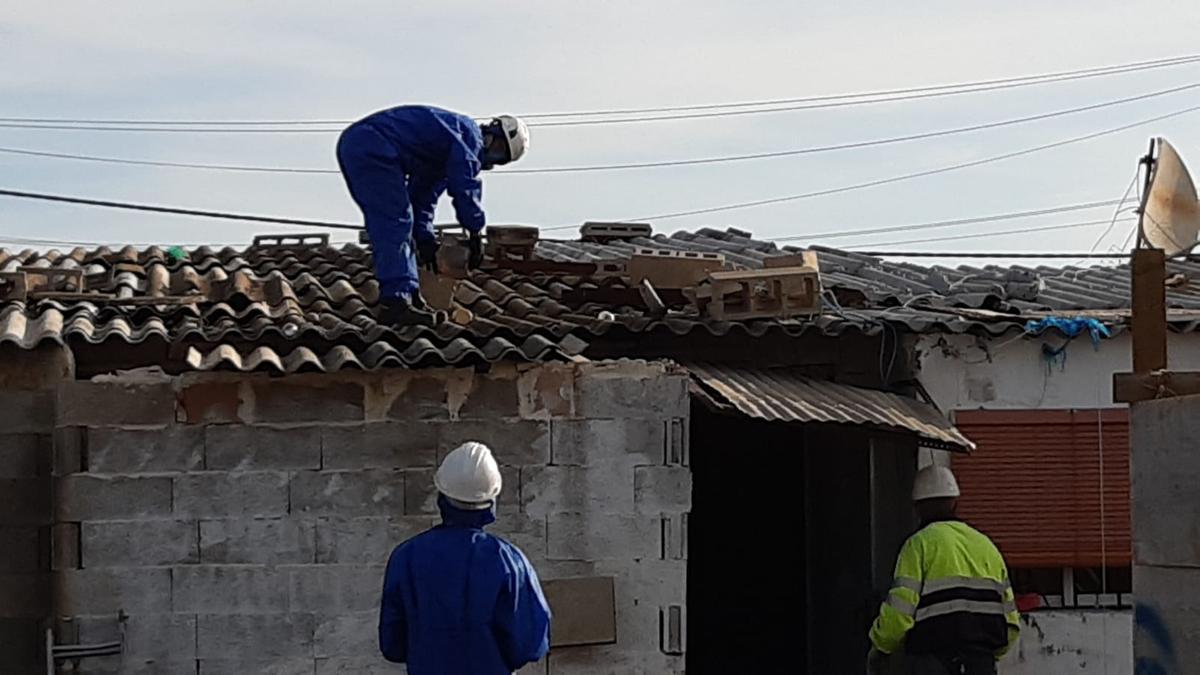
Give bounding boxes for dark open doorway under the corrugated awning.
[688,404,916,675]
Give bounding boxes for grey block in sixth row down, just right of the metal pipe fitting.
[196,614,313,661]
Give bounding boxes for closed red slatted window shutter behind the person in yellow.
[953,408,1133,567]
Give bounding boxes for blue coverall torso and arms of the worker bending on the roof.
[361,106,486,232]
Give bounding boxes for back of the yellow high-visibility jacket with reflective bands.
[901,520,1012,653]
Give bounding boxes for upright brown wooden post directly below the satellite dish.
[1130,249,1166,374]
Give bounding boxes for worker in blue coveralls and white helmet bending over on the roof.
[337,106,529,324]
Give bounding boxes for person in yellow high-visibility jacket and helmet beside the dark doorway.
[868,466,1020,675]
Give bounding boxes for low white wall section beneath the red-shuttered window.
[1000,610,1133,675]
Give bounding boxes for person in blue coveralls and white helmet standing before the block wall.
[379,442,550,675]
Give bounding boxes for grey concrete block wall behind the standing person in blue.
[52,362,690,675]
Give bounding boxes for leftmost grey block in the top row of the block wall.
[58,381,175,426]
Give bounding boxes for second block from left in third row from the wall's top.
[174,471,288,518]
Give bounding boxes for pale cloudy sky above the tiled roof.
[0,0,1200,264]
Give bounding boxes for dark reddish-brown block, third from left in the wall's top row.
[251,377,365,424]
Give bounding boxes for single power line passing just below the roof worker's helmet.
[7,83,1200,175]
